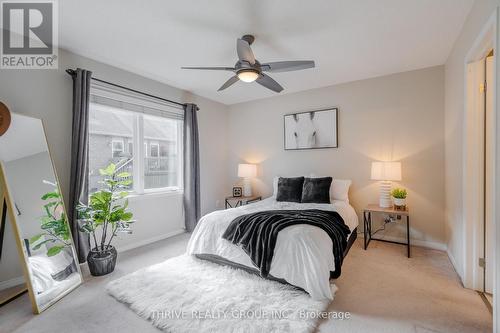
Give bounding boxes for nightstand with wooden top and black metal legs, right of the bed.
[363,205,410,258]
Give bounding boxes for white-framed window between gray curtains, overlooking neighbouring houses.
[89,82,183,194]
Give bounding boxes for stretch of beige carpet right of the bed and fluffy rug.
[319,241,493,333]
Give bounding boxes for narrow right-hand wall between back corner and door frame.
[445,0,500,278]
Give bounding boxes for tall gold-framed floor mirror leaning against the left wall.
[0,113,83,313]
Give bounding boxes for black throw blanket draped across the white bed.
[222,209,350,279]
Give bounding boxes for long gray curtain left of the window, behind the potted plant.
[67,68,92,263]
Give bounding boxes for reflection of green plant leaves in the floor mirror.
[29,182,71,257]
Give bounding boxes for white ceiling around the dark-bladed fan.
[59,0,474,104]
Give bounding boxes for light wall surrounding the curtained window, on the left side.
[0,50,228,249]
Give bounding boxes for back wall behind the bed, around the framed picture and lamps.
[229,66,445,248]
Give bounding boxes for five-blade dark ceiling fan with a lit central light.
[181,35,314,93]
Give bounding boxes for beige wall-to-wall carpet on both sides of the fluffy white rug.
[0,235,492,333]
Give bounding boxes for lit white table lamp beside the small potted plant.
[371,162,401,208]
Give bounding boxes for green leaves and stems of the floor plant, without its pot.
[77,163,135,252]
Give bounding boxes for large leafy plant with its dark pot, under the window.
[77,163,135,276]
